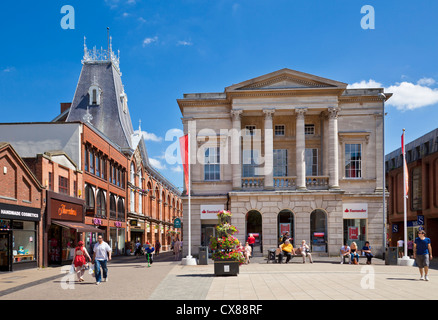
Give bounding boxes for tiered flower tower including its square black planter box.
[210,210,245,276]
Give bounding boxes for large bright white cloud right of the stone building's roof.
[347,78,438,111]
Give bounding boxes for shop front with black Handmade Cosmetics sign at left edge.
[0,203,41,271]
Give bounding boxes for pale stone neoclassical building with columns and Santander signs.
[177,69,391,255]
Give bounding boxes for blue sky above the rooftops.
[0,0,438,187]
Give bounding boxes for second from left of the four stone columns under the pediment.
[263,109,275,190]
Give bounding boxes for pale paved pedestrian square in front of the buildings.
[0,253,438,301]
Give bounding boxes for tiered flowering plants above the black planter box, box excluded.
[210,210,245,264]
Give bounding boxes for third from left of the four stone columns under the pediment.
[295,108,307,190]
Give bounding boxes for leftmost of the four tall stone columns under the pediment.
[231,110,243,190]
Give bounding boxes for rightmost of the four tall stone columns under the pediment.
[328,107,339,189]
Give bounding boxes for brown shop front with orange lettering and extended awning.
[45,191,100,265]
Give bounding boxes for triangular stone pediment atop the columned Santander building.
[225,69,347,92]
